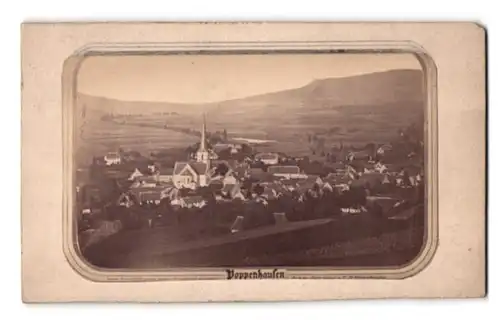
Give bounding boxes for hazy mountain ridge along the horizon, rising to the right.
[77,69,424,114]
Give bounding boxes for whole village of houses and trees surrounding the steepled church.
[75,117,424,252]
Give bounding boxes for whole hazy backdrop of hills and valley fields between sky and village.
[77,70,423,165]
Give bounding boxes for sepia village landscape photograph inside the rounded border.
[74,53,427,270]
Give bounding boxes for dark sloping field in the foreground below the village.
[85,212,424,269]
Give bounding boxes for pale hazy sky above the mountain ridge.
[77,54,421,103]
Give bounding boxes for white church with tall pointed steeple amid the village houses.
[172,115,214,189]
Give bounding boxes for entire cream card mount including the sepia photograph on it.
[22,23,485,302]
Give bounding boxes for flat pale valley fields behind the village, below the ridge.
[78,106,419,165]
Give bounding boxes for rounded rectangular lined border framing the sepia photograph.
[62,41,438,282]
